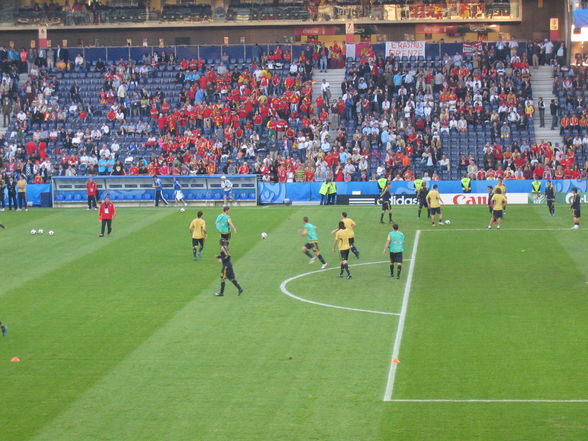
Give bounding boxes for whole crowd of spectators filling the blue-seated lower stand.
[0,37,588,187]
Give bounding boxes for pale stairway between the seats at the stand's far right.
[531,66,562,145]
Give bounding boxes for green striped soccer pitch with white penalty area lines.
[0,206,588,441]
